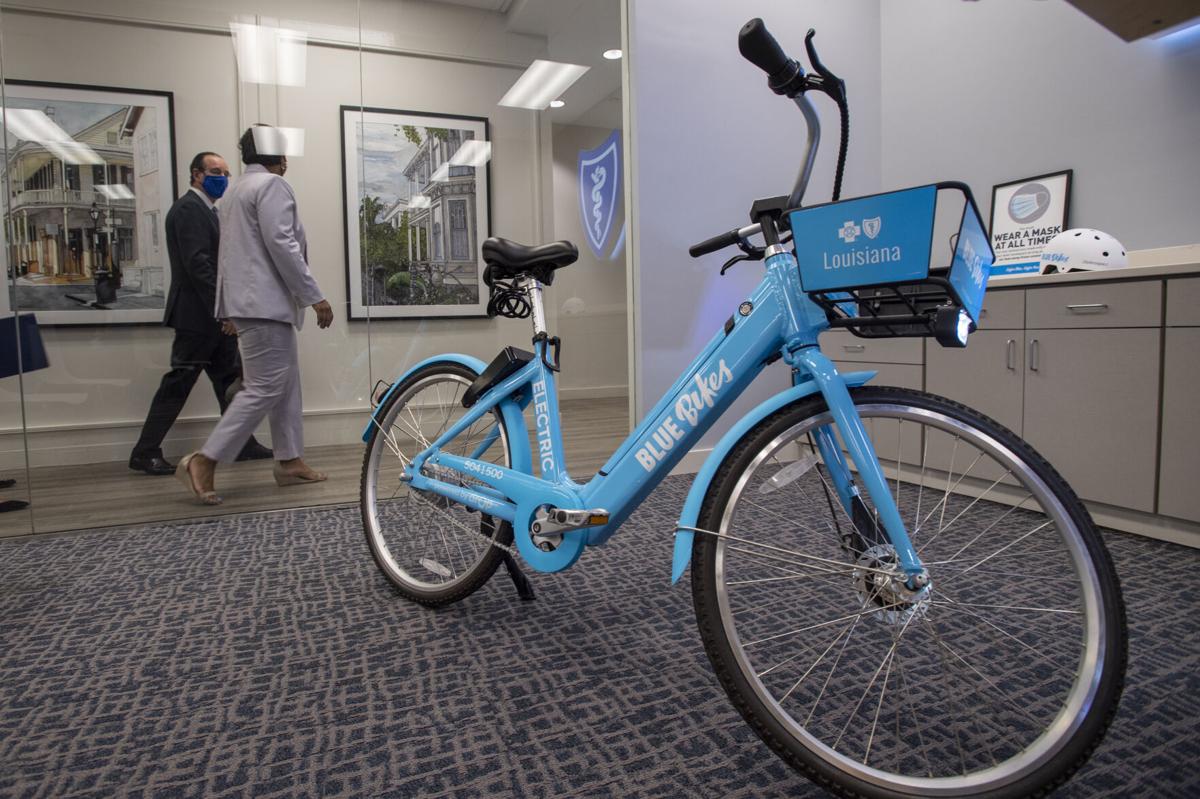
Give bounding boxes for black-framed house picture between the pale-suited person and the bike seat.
[341,106,492,319]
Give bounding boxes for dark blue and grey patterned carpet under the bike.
[0,479,1200,799]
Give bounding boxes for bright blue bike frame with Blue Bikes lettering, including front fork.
[379,245,922,575]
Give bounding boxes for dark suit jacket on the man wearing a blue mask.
[163,190,221,334]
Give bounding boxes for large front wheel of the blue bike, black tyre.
[691,388,1126,797]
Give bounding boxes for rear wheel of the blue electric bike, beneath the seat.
[360,361,512,607]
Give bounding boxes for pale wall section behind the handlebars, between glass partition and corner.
[629,0,881,446]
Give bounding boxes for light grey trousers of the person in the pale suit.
[200,319,304,463]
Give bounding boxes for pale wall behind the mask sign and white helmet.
[880,0,1200,250]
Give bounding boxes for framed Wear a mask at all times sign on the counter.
[990,169,1072,277]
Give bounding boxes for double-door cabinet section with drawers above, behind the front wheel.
[925,281,1163,512]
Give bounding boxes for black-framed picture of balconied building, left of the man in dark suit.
[0,80,176,325]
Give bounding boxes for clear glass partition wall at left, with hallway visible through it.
[0,0,628,535]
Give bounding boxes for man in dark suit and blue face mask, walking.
[130,152,271,475]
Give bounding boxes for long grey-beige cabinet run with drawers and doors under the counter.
[822,272,1200,541]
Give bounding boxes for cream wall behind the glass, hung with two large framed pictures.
[0,0,580,468]
